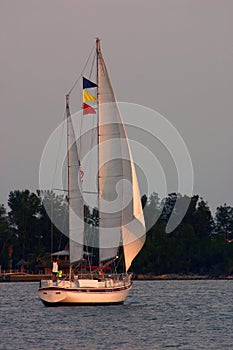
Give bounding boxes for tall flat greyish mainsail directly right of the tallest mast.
[97,45,123,261]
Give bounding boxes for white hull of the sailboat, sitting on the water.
[38,280,132,306]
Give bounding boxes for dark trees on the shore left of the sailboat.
[0,190,68,270]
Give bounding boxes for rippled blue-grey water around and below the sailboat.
[0,281,233,350]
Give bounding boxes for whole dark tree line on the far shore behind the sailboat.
[0,190,233,276]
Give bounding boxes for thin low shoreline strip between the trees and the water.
[0,273,233,283]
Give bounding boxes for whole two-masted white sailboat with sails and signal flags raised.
[38,38,146,306]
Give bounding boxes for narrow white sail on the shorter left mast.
[67,98,84,263]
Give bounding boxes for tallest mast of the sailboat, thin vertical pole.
[96,37,100,261]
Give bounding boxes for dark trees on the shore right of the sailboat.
[133,193,233,276]
